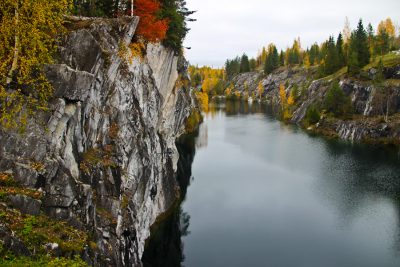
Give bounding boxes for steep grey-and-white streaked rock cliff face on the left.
[0,18,193,266]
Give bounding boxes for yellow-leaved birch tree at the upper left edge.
[0,0,71,130]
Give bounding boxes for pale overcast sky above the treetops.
[185,0,400,67]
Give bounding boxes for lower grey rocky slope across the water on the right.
[231,65,400,144]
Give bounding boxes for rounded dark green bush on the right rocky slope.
[324,82,352,116]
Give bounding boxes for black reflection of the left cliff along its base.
[142,134,197,267]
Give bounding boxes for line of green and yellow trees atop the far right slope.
[225,18,400,79]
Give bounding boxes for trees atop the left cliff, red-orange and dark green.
[72,0,194,53]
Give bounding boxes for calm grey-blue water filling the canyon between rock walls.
[143,102,400,267]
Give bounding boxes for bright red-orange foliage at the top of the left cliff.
[135,0,168,42]
